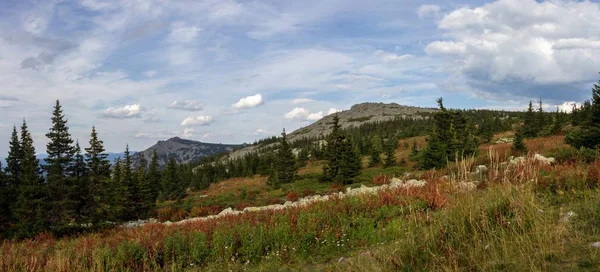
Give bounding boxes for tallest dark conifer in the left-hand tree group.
[43,100,77,227]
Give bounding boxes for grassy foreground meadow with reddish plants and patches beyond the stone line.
[0,134,600,271]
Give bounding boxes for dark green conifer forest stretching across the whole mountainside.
[0,85,600,238]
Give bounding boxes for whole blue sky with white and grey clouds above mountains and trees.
[0,0,600,157]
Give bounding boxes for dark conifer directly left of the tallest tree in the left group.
[13,120,47,238]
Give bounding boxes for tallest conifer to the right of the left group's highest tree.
[83,127,111,223]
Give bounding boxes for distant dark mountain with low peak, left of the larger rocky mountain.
[132,137,244,168]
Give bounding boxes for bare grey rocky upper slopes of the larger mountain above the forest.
[229,103,437,158]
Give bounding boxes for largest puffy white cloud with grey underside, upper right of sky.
[425,0,600,101]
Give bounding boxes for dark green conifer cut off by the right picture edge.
[565,78,600,150]
